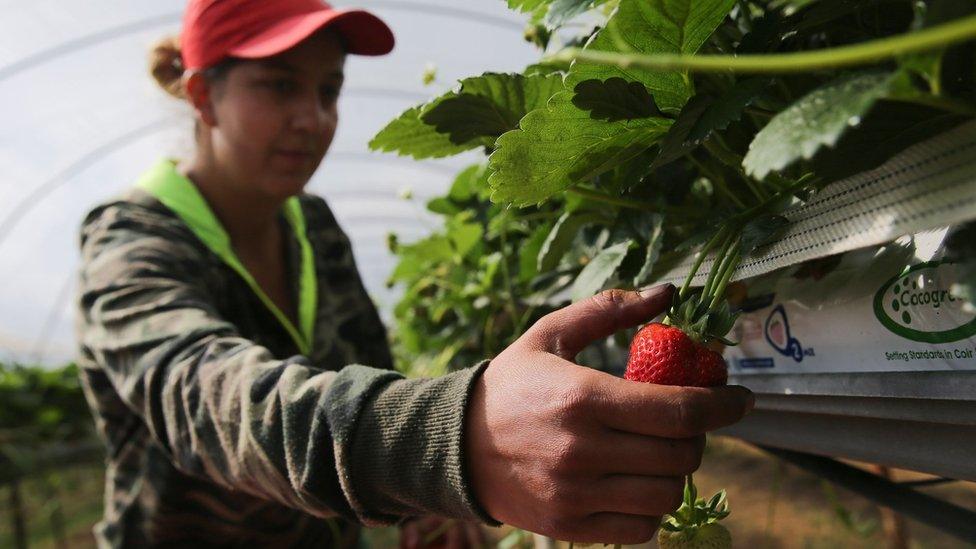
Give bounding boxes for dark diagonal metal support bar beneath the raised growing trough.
[757,445,976,543]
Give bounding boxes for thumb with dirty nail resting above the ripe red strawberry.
[526,284,674,360]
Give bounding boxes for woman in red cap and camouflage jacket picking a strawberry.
[78,0,747,547]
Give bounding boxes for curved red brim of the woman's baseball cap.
[227,10,395,59]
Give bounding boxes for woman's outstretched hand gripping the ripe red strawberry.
[465,286,753,543]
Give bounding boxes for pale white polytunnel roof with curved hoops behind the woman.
[0,0,538,364]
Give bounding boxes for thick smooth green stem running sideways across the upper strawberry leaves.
[550,15,976,74]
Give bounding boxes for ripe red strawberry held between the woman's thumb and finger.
[624,323,727,387]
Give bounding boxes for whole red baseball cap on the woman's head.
[180,0,394,70]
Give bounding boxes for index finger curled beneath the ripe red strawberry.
[597,375,755,438]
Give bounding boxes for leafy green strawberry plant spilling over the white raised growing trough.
[371,0,976,544]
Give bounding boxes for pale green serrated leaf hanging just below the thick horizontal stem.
[742,72,892,179]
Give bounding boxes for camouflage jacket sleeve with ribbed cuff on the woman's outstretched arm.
[78,205,494,525]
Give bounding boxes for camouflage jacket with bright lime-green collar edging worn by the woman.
[77,157,492,547]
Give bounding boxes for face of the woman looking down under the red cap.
[211,28,345,200]
